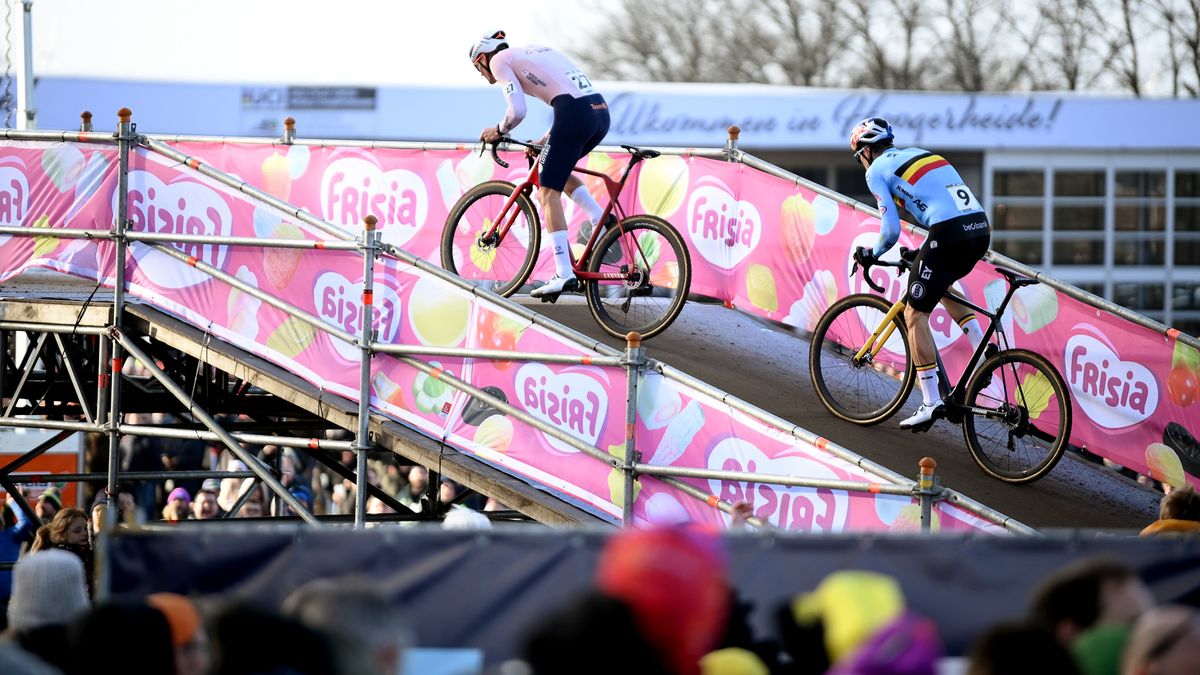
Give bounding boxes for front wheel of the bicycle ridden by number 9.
[809,293,914,426]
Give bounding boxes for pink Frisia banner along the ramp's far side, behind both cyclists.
[179,143,1200,485]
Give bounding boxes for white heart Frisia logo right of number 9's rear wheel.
[1063,324,1158,429]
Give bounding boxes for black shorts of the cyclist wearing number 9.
[908,213,991,312]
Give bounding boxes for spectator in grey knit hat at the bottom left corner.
[6,549,88,669]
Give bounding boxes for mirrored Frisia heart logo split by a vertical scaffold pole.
[312,271,401,362]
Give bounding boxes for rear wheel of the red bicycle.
[586,215,691,339]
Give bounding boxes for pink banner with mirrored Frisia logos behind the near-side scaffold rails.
[0,143,1002,533]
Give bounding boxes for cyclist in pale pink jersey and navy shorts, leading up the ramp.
[470,30,616,298]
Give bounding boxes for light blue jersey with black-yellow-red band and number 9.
[866,148,990,257]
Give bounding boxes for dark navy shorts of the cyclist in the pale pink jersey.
[538,94,608,192]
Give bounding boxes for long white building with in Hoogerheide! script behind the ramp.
[25,78,1200,335]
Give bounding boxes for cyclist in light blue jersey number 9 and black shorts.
[850,118,991,431]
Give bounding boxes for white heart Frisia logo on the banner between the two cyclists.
[686,178,762,269]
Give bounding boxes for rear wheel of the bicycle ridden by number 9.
[962,350,1072,484]
